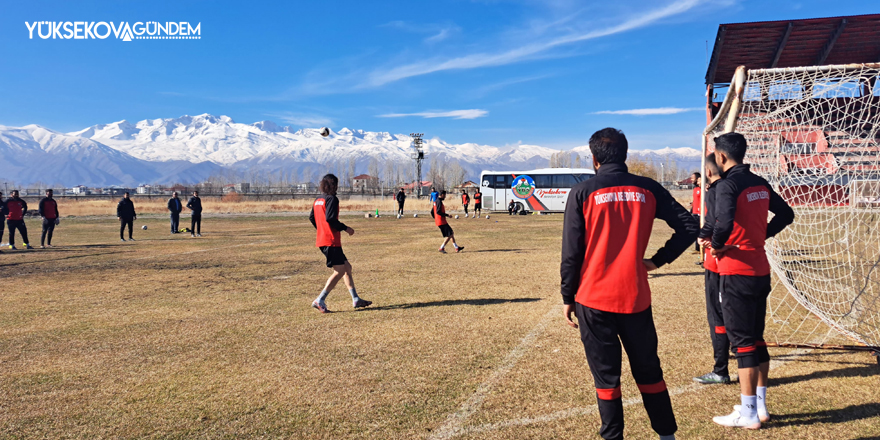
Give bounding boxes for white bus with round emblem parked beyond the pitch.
[480,168,596,212]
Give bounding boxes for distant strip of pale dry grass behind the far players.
[49,196,431,217]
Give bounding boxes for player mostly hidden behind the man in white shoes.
[694,153,730,384]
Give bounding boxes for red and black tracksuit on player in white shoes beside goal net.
[712,165,794,368]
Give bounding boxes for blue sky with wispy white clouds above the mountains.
[0,0,878,149]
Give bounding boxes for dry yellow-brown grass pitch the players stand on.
[0,212,880,440]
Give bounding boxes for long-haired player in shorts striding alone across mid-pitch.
[309,174,373,313]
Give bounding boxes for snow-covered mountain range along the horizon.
[0,114,700,186]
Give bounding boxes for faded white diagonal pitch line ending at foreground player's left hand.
[429,305,562,440]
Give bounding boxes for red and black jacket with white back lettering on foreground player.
[561,164,699,313]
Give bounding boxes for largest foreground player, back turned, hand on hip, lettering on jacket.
[560,128,699,439]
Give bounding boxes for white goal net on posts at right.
[704,64,880,347]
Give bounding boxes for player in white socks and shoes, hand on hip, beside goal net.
[711,133,794,429]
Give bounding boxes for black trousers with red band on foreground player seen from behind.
[575,304,678,440]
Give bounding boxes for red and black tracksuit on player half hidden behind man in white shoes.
[698,180,730,376]
